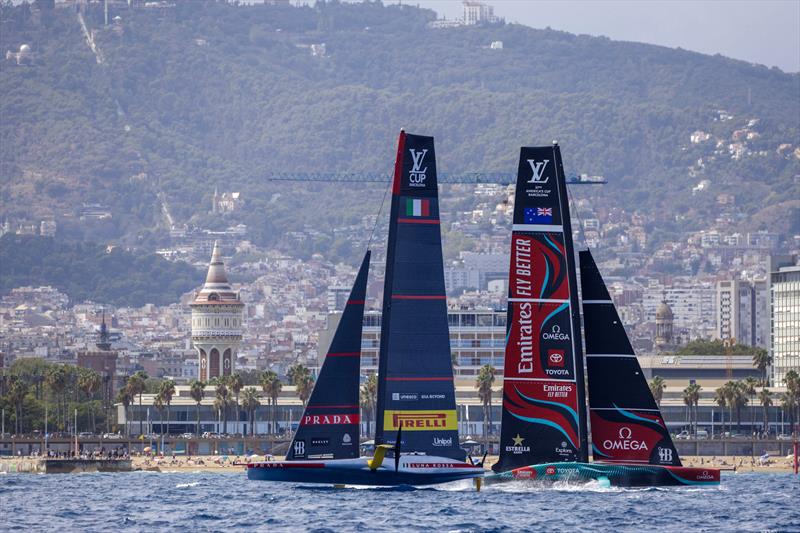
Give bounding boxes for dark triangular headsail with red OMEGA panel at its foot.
[580,250,681,466]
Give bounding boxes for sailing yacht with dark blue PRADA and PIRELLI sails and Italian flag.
[247,130,485,485]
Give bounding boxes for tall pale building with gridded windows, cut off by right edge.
[768,255,800,385]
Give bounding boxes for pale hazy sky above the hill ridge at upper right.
[396,0,800,72]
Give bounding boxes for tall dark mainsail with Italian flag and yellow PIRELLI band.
[375,131,465,459]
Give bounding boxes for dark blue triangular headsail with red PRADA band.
[286,250,370,461]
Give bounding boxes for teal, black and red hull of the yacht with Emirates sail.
[484,462,720,487]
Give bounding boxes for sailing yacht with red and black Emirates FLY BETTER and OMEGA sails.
[485,144,720,486]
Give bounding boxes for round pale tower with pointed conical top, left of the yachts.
[189,241,244,381]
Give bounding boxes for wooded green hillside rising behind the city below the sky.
[0,1,800,254]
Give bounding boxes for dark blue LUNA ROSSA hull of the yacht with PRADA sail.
[247,456,485,486]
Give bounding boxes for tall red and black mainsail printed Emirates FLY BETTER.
[493,146,588,472]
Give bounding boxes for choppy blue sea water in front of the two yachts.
[0,472,800,532]
